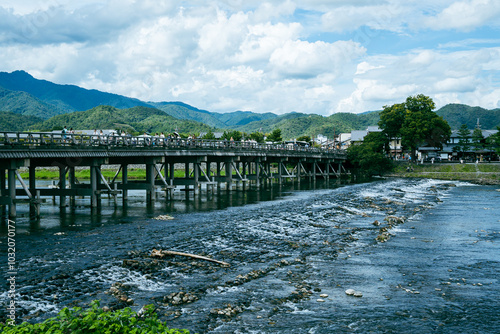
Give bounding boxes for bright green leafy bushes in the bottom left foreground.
[0,301,189,334]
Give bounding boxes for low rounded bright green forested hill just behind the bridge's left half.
[30,106,211,133]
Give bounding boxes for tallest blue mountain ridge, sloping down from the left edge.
[0,71,149,118]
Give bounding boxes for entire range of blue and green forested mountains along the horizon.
[0,71,500,139]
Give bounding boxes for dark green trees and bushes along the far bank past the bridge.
[348,94,500,176]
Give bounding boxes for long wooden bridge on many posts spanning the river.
[0,132,346,219]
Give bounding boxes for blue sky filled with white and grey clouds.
[0,0,500,116]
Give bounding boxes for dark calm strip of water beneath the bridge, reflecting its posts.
[0,180,341,235]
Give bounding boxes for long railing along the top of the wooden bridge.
[0,132,345,155]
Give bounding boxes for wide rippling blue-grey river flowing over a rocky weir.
[0,179,500,333]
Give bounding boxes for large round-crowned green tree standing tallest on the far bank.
[378,94,451,161]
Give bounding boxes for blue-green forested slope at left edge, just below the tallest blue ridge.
[0,87,61,118]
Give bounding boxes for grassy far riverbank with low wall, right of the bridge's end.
[384,163,500,185]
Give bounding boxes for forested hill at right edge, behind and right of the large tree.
[436,104,500,130]
